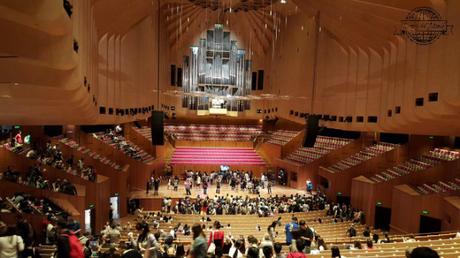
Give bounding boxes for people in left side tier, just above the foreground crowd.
[0,164,77,195]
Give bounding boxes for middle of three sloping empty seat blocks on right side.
[327,142,398,173]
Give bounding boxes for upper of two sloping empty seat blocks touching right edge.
[370,148,458,183]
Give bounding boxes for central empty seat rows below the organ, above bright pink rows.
[163,124,262,141]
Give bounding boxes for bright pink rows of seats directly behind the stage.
[171,147,265,165]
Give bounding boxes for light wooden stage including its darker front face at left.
[130,181,306,210]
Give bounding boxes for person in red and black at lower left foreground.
[55,221,85,258]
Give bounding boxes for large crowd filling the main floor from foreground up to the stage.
[0,189,446,258]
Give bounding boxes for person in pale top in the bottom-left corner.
[0,221,24,258]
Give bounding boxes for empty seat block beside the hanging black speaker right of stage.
[286,136,351,164]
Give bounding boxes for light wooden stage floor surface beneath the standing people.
[130,182,306,199]
